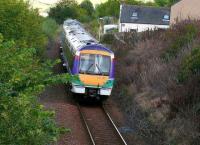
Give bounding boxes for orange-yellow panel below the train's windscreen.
[79,74,109,86]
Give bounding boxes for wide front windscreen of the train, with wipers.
[79,54,111,76]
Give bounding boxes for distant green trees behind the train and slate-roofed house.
[49,0,170,24]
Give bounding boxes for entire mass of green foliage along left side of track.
[0,0,70,145]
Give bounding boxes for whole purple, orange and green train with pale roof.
[61,19,114,100]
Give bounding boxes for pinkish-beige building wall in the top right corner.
[170,0,200,24]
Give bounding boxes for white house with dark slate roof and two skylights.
[119,4,170,32]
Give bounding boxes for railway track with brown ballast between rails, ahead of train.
[77,104,127,145]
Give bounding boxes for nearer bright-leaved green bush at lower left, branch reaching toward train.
[0,35,69,145]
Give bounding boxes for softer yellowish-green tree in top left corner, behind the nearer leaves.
[0,0,46,54]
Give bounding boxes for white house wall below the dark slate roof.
[119,23,169,32]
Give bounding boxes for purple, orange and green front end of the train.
[72,45,114,98]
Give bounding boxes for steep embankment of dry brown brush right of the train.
[107,20,200,145]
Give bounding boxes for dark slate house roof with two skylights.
[120,4,170,25]
